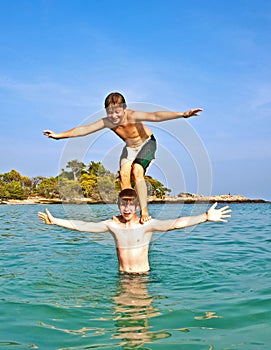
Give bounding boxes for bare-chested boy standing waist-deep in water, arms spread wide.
[38,188,231,273]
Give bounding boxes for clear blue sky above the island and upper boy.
[0,0,271,200]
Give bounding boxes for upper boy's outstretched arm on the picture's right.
[132,108,202,122]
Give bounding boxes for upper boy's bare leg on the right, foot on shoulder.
[132,163,151,224]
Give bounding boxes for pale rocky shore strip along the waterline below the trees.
[0,193,270,204]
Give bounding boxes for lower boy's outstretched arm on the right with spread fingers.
[151,203,231,231]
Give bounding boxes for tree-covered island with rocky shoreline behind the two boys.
[0,160,270,204]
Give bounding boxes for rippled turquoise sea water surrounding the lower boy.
[0,204,271,350]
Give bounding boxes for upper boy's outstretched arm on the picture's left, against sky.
[43,119,106,140]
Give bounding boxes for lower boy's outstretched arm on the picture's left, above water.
[38,209,108,233]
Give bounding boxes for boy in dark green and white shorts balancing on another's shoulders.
[43,92,202,224]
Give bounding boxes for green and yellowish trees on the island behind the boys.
[0,160,171,202]
